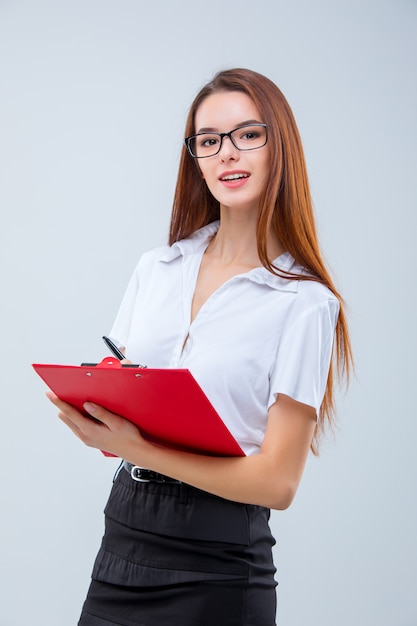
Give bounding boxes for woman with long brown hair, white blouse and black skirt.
[49,69,351,626]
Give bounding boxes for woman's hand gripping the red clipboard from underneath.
[46,392,147,459]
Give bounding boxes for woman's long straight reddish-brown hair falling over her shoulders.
[169,69,352,454]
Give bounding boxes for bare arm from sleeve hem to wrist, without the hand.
[123,396,315,509]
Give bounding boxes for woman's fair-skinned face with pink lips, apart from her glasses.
[195,91,269,211]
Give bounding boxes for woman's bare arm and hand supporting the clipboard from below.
[47,393,316,509]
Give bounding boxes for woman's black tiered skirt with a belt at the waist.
[79,460,276,626]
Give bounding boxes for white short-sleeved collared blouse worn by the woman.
[110,222,339,455]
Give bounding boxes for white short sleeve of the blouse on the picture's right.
[268,298,339,413]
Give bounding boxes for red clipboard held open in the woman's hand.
[33,357,245,456]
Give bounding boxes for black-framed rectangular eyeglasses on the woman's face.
[184,124,268,159]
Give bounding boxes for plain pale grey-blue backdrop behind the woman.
[0,0,417,626]
